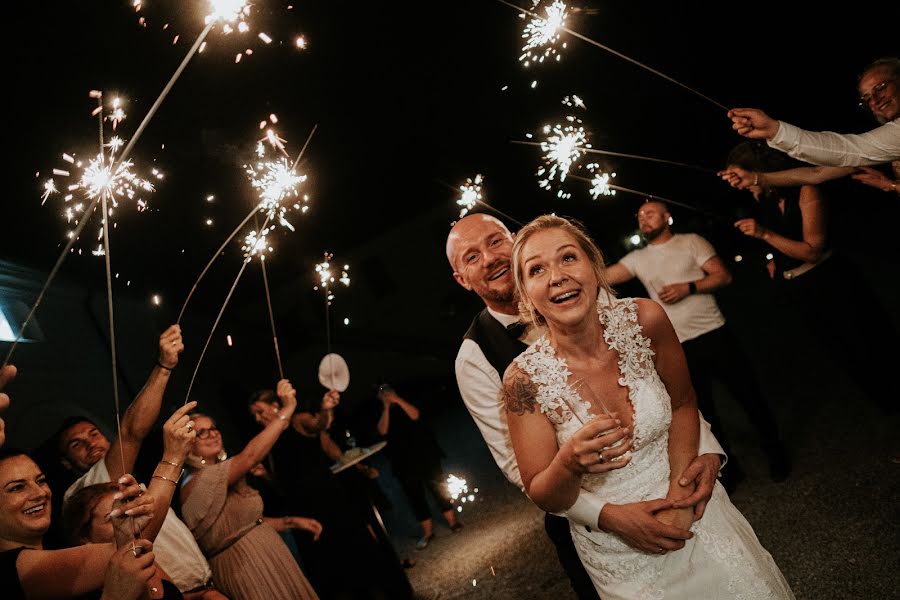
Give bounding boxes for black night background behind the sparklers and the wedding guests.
[0,0,900,445]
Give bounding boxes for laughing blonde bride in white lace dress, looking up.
[503,215,794,600]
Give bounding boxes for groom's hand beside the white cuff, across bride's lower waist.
[597,498,694,554]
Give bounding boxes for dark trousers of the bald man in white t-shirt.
[681,324,782,459]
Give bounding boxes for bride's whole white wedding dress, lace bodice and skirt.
[516,298,794,600]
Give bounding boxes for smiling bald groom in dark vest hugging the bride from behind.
[447,213,724,599]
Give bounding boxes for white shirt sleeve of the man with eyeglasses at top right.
[768,119,900,167]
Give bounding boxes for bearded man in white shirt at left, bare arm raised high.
[58,325,225,600]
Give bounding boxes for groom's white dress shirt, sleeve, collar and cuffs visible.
[456,308,726,528]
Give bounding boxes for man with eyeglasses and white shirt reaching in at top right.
[728,57,900,172]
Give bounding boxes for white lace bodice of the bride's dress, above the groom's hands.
[515,298,672,503]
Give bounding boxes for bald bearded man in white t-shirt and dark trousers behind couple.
[606,199,791,487]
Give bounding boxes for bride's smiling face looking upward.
[521,229,598,326]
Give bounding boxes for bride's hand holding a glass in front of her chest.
[560,413,633,475]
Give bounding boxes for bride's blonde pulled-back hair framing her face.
[512,215,616,326]
